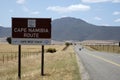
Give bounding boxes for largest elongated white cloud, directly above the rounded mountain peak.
[47,4,90,13]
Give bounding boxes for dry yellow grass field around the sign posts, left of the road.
[0,44,81,80]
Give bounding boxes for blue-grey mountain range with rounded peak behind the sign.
[0,17,120,40]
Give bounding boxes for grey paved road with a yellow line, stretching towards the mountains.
[74,45,120,80]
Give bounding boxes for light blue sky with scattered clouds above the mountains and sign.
[0,0,120,27]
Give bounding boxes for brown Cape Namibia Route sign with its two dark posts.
[11,18,51,79]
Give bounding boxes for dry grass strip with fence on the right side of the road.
[86,45,120,54]
